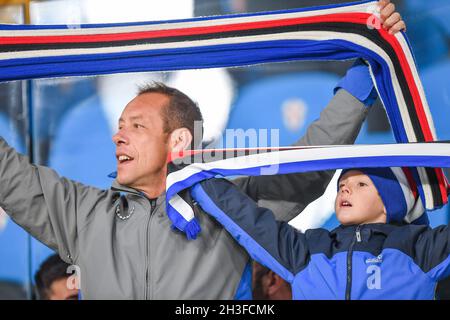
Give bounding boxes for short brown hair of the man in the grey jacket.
[138,82,203,148]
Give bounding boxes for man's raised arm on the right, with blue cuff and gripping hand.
[233,0,406,221]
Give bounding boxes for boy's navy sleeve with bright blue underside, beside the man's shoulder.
[191,179,309,282]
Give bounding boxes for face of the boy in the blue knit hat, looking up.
[334,170,386,225]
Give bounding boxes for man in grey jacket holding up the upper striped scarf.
[0,1,404,299]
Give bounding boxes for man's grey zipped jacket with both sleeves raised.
[0,90,367,299]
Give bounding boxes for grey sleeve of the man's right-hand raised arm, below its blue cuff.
[233,89,368,221]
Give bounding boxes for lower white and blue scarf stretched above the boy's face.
[166,142,450,239]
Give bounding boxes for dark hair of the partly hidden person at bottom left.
[34,254,70,300]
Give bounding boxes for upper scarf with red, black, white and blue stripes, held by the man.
[0,1,447,236]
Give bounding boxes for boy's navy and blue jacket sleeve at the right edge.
[414,226,450,281]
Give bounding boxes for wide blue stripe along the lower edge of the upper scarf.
[0,35,408,146]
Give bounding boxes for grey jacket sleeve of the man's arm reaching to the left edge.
[0,137,106,263]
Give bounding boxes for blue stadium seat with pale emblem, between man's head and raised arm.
[227,72,339,147]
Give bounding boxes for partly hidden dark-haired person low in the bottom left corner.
[34,254,78,300]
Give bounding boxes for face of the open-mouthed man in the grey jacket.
[113,93,169,190]
